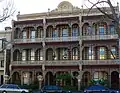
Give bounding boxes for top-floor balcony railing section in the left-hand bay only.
[14,38,43,43]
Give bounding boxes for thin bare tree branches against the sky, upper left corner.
[0,0,15,22]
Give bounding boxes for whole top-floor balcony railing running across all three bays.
[14,34,118,43]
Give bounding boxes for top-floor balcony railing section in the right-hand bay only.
[81,34,118,40]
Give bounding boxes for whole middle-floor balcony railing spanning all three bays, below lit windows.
[11,60,119,66]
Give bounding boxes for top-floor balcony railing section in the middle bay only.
[45,36,79,42]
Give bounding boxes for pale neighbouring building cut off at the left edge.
[0,27,12,85]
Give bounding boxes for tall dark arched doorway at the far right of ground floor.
[111,71,119,89]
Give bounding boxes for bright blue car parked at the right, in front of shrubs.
[84,85,119,93]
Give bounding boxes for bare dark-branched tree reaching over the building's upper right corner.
[87,0,120,38]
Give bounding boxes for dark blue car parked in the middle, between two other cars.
[41,85,71,93]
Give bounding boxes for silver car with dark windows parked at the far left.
[0,84,29,93]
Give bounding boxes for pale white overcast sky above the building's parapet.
[0,0,120,30]
